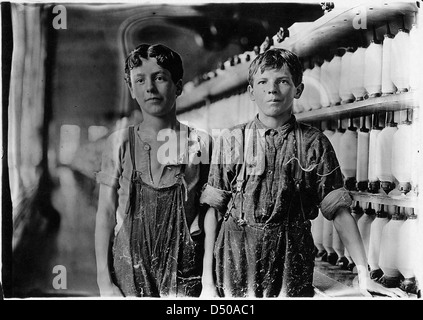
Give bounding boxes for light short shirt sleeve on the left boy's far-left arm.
[96,132,122,188]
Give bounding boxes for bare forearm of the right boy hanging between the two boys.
[202,208,217,285]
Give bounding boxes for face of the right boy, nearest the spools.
[248,65,304,118]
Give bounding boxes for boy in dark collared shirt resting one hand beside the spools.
[201,49,401,297]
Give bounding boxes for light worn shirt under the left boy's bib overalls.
[96,124,212,234]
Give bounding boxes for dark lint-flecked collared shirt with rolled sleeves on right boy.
[201,116,351,223]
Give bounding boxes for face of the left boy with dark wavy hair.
[129,58,182,117]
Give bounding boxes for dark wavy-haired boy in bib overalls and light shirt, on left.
[95,44,210,297]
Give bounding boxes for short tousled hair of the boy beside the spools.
[248,48,303,86]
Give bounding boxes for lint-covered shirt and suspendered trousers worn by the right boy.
[201,116,351,297]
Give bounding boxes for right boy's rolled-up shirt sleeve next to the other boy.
[200,131,238,213]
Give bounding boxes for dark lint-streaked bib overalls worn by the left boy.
[112,126,202,297]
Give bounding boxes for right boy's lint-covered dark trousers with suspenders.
[214,120,314,297]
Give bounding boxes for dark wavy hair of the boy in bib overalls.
[125,43,184,85]
